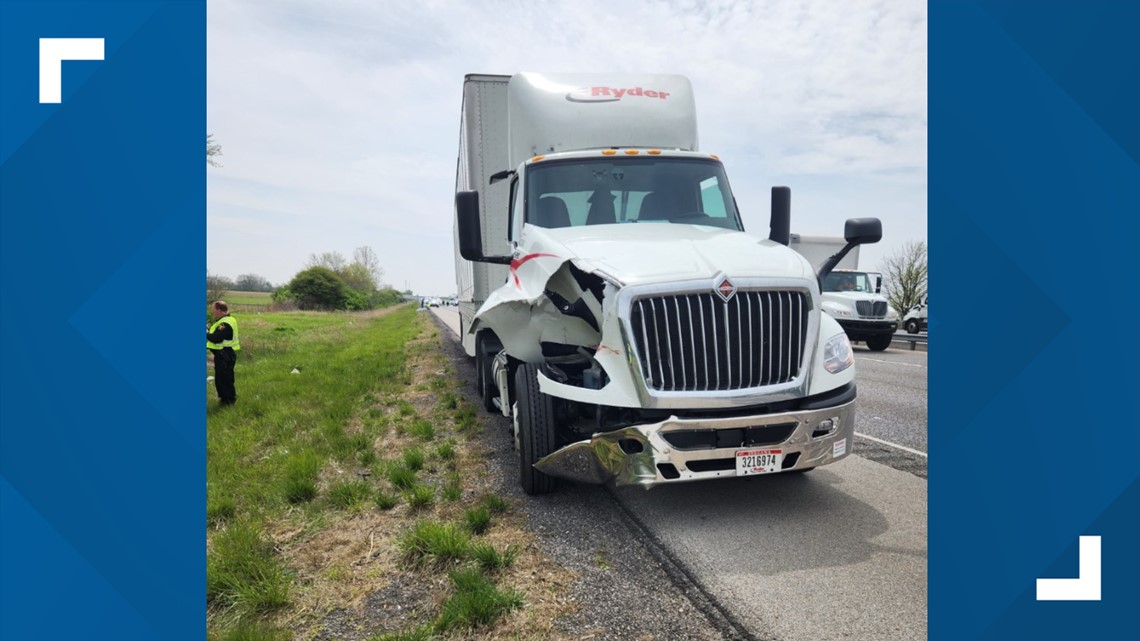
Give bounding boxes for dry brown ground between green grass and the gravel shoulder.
[267,315,576,641]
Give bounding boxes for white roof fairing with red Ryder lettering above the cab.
[500,73,698,169]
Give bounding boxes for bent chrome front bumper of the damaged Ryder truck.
[535,400,855,487]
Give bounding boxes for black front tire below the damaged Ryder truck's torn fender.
[514,363,557,494]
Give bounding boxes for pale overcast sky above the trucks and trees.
[206,0,927,295]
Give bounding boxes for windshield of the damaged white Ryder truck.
[526,156,742,230]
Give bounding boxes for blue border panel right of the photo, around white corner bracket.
[929,1,1140,641]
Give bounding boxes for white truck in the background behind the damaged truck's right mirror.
[788,234,898,351]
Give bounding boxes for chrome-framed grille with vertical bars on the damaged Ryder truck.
[629,291,811,391]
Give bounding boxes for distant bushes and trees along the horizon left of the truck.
[206,246,404,311]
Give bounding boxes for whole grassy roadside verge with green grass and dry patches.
[206,306,570,641]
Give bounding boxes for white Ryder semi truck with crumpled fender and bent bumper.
[455,73,882,494]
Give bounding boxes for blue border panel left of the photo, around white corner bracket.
[0,0,206,640]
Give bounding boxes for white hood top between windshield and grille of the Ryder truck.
[521,224,815,285]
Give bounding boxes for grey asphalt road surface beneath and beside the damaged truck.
[435,308,927,641]
